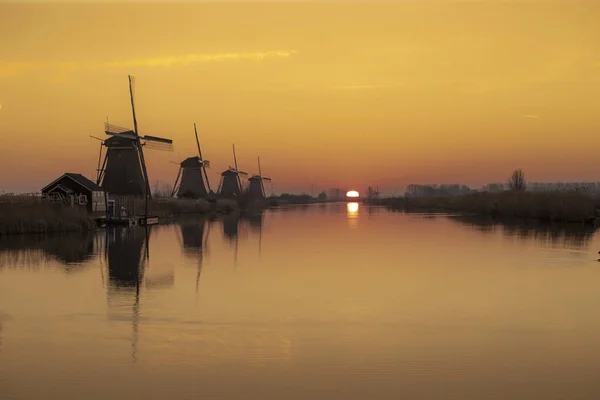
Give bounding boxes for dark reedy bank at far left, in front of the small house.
[0,196,95,236]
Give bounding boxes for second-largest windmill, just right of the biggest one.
[171,123,210,199]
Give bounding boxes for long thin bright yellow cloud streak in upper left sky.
[0,50,298,78]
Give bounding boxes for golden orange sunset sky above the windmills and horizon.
[0,0,600,192]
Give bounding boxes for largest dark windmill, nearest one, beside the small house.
[97,75,173,202]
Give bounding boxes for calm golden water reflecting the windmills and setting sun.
[0,204,600,400]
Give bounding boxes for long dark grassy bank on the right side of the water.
[379,191,598,222]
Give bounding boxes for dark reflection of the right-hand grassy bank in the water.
[448,215,597,248]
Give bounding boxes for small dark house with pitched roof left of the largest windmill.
[42,172,106,216]
